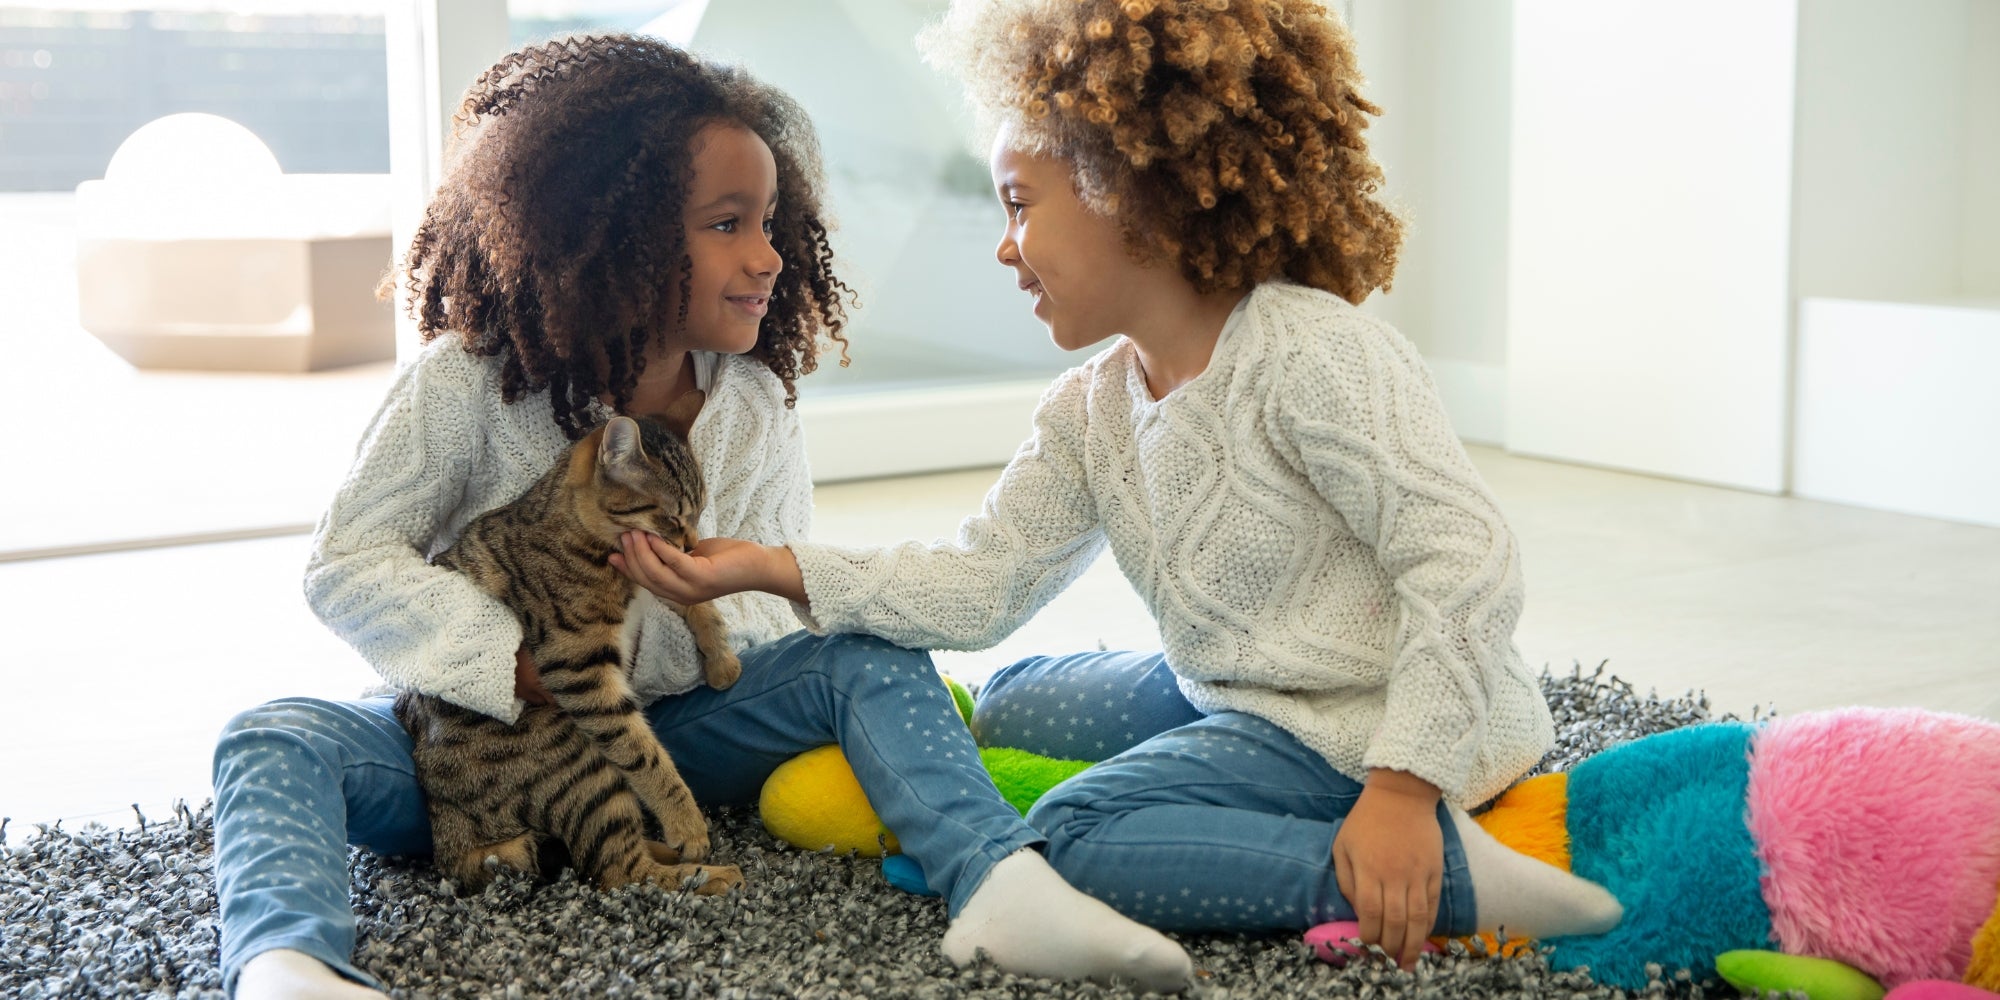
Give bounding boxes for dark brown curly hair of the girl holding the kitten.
[404,34,852,438]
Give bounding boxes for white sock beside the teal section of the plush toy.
[1452,806,1624,940]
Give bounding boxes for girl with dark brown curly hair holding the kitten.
[214,36,1188,998]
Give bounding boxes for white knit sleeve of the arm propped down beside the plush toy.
[1266,312,1522,800]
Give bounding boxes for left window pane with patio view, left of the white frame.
[0,0,404,558]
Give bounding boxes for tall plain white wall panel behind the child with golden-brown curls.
[1506,0,1796,492]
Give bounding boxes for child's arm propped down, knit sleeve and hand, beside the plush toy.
[1270,308,1522,968]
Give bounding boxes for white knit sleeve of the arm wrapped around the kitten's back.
[306,344,522,722]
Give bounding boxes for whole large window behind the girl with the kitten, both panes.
[0,0,1078,558]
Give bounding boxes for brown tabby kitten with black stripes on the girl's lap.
[396,394,742,894]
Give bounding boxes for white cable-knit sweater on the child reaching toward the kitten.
[792,284,1554,804]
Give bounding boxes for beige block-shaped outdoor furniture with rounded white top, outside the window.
[76,114,396,372]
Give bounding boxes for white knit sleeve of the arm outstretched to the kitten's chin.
[792,368,1104,650]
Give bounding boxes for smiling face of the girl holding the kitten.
[668,122,784,354]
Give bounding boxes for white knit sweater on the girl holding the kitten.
[306,336,812,722]
